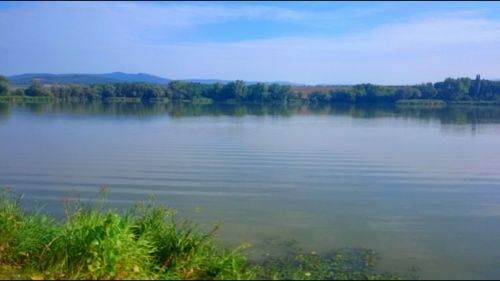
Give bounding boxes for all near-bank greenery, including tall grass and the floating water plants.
[0,191,408,280]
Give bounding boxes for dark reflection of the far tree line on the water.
[0,98,500,124]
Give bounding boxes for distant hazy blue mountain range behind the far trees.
[7,72,299,86]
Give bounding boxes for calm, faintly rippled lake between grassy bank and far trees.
[0,103,500,279]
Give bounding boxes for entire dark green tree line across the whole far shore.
[0,75,500,104]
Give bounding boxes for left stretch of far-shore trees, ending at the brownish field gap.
[3,80,299,103]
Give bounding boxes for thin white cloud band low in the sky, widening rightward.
[131,12,500,84]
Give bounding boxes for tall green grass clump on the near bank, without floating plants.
[0,189,255,280]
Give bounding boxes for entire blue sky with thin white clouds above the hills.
[0,1,500,84]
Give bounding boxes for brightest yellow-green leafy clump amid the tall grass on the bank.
[46,207,153,279]
